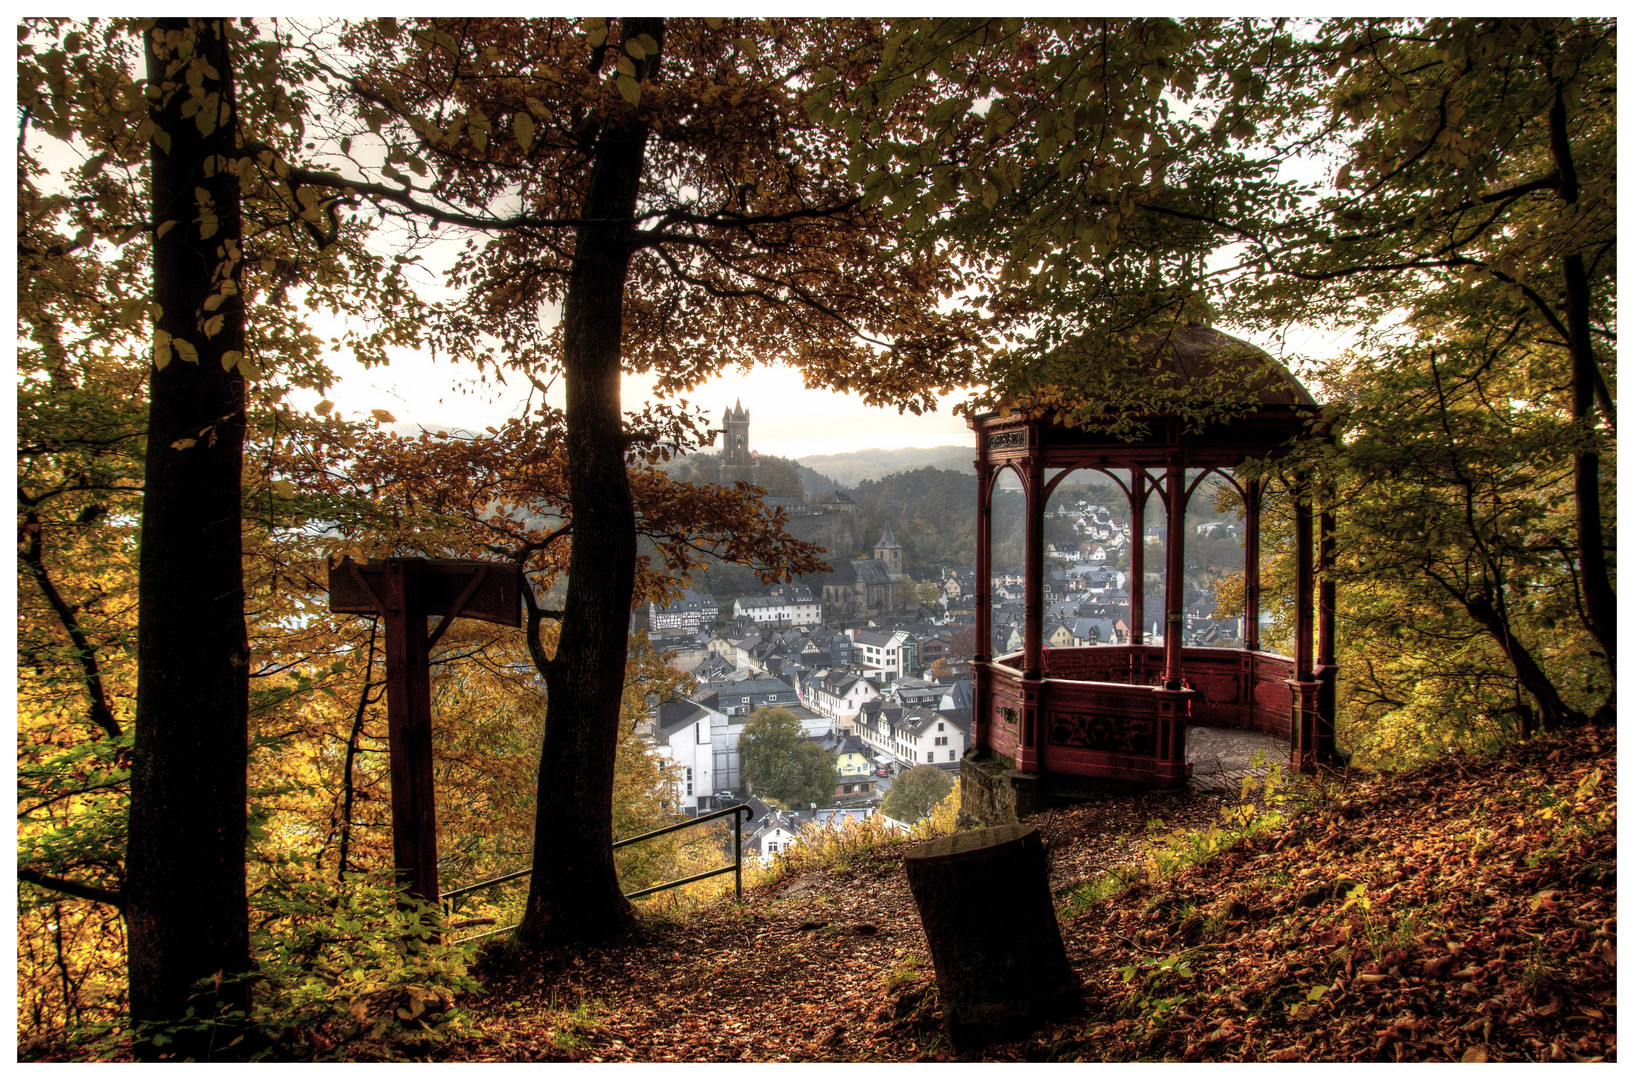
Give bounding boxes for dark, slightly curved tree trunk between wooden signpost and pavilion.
[516,20,663,944]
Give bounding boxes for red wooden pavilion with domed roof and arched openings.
[962,327,1338,823]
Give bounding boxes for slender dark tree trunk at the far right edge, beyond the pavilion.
[1549,87,1618,675]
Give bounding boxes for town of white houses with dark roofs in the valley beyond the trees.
[632,402,1242,859]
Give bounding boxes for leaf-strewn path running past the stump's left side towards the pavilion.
[454,791,1221,1062]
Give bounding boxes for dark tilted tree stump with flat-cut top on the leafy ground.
[904,825,1083,1054]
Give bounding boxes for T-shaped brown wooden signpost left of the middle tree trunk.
[328,556,523,904]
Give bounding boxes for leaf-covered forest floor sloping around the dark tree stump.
[454,729,1616,1062]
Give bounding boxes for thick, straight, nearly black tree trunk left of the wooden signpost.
[124,18,250,1055]
